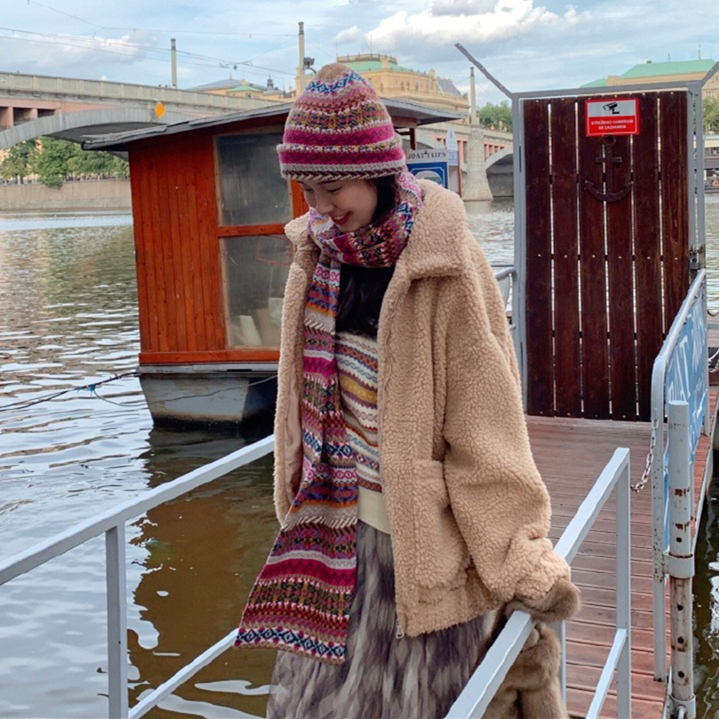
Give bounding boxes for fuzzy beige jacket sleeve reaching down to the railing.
[444,243,569,603]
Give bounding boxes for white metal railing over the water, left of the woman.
[0,435,275,719]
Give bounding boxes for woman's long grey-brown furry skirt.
[267,522,493,719]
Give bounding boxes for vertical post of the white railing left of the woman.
[105,522,129,719]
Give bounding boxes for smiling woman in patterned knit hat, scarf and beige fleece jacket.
[237,65,578,719]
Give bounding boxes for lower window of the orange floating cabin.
[222,235,291,348]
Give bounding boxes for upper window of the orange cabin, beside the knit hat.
[217,132,292,226]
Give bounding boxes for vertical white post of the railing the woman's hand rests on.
[617,461,632,717]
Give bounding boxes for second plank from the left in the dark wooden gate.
[552,98,582,417]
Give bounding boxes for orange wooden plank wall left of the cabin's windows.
[130,134,231,363]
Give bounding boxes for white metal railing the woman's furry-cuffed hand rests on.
[446,449,631,719]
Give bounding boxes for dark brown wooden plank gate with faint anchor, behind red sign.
[522,91,689,420]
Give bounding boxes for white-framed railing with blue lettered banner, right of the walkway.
[650,270,710,682]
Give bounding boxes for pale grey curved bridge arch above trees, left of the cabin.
[0,107,198,150]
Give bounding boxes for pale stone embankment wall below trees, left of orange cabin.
[0,180,132,212]
